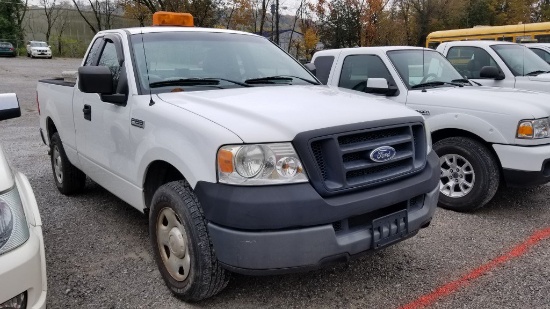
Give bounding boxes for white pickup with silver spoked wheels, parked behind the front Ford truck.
[312,47,550,211]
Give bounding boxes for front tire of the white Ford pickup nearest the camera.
[149,181,230,302]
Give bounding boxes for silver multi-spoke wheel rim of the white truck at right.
[439,154,476,198]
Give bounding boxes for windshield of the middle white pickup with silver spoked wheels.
[388,49,471,89]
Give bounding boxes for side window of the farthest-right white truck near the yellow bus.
[447,46,499,78]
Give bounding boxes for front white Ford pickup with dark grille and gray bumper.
[38,13,439,301]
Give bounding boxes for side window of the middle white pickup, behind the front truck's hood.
[338,55,395,90]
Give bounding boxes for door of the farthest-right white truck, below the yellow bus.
[446,46,516,88]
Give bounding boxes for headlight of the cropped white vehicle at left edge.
[0,187,29,255]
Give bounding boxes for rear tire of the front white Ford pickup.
[50,132,86,195]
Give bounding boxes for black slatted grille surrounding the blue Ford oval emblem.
[310,123,426,192]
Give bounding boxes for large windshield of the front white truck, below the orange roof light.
[131,31,318,93]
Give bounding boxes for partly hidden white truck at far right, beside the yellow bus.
[437,41,550,92]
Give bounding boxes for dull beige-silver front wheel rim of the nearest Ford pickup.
[157,207,191,281]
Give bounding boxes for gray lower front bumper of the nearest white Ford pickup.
[208,184,439,274]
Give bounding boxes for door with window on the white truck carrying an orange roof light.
[74,34,134,189]
